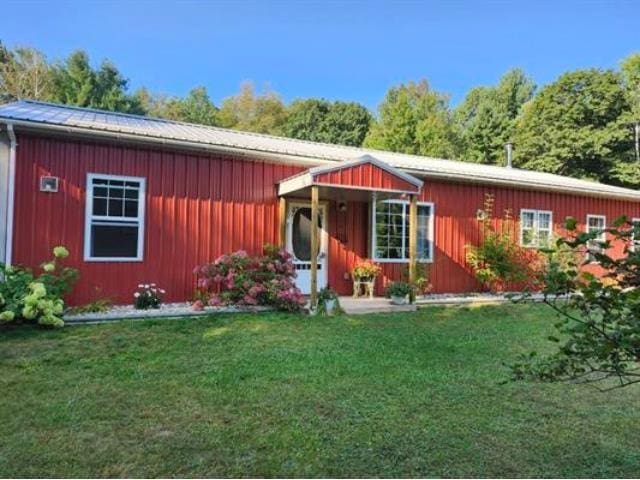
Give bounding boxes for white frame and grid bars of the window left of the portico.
[84,173,147,262]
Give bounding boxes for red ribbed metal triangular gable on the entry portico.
[313,163,419,193]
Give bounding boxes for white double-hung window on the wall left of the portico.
[84,173,145,262]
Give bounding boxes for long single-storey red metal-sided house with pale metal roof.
[0,101,640,303]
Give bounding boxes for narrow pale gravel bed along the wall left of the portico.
[63,302,273,324]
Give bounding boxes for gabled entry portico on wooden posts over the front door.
[278,155,423,306]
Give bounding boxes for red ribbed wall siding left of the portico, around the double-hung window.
[14,135,302,303]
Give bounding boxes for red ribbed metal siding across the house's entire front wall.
[14,131,640,303]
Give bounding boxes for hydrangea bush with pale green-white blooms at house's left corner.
[0,246,78,327]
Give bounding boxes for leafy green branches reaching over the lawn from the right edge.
[510,217,640,390]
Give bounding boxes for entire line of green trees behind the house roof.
[0,42,640,187]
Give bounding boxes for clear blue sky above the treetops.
[0,0,640,109]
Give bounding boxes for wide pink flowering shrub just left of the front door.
[194,245,304,311]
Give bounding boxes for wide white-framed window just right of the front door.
[372,200,433,262]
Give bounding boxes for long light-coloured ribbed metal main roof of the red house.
[0,100,640,200]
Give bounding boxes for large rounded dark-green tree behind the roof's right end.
[515,69,630,181]
